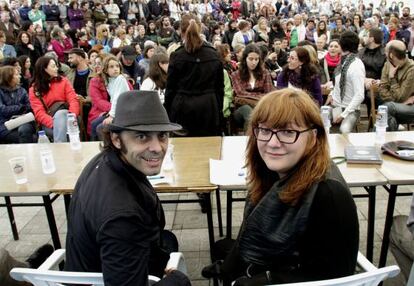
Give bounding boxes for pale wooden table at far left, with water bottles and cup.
[0,143,99,248]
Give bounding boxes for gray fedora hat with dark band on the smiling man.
[109,90,182,132]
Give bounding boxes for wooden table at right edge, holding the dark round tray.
[347,131,414,267]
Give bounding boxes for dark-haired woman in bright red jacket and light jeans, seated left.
[29,57,79,142]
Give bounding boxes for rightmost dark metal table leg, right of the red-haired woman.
[378,185,397,267]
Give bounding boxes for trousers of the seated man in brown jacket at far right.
[384,102,414,131]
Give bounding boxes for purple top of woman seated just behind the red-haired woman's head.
[277,70,323,106]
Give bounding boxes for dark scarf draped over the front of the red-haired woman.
[239,174,318,265]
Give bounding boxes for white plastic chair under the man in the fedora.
[10,249,187,286]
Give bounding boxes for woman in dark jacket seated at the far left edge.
[0,66,36,143]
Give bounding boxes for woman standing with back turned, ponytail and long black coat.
[165,15,224,136]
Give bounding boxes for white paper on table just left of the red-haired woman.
[210,159,246,186]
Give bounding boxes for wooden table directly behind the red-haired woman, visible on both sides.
[219,134,387,261]
